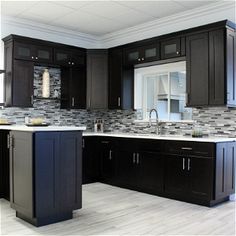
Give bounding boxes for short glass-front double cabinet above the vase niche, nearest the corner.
[54,48,85,67]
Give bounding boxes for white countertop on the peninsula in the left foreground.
[0,125,86,132]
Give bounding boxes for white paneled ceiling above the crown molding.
[1,0,221,36]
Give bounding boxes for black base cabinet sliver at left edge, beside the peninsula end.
[0,130,10,200]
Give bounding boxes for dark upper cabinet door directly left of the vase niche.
[12,60,34,107]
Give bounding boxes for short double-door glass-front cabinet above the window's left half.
[124,41,160,66]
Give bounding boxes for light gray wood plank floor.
[0,183,235,235]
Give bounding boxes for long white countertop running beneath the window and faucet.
[83,132,236,143]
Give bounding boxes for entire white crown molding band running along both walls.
[1,0,236,49]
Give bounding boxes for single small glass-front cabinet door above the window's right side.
[161,38,181,59]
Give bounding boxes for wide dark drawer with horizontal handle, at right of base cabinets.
[166,141,215,157]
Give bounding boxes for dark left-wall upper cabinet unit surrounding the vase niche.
[3,35,86,108]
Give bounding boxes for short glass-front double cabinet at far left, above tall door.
[14,42,53,63]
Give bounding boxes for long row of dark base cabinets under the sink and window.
[84,137,236,206]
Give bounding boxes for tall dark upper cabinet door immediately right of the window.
[186,33,209,106]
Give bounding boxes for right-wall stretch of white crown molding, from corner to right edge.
[100,1,236,48]
